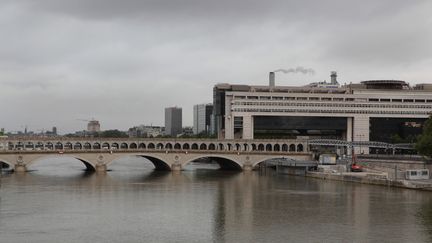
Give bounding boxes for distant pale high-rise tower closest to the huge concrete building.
[193,103,213,134]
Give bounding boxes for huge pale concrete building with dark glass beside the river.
[213,72,432,153]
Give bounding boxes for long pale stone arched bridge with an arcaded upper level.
[0,137,311,171]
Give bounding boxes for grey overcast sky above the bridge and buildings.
[0,0,432,133]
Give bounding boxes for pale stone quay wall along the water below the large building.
[305,171,432,191]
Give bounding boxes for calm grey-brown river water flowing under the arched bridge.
[0,158,432,243]
